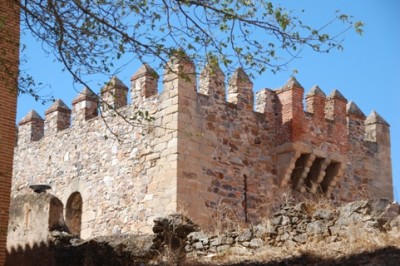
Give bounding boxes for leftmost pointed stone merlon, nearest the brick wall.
[18,110,44,145]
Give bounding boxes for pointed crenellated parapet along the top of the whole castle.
[18,56,388,154]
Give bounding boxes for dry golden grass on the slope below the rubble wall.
[185,192,400,265]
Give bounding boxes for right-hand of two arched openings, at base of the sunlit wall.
[65,192,82,236]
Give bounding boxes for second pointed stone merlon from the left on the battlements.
[44,99,71,136]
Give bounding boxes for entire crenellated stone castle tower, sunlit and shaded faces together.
[8,58,393,245]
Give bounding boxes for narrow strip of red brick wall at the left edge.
[0,0,19,265]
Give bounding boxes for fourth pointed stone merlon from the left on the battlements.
[100,76,128,111]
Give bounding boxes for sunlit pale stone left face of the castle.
[13,69,177,238]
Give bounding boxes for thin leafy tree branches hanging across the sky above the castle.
[14,0,363,91]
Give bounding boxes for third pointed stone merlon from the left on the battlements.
[72,87,99,126]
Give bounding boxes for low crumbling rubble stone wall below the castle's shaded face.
[185,199,400,257]
